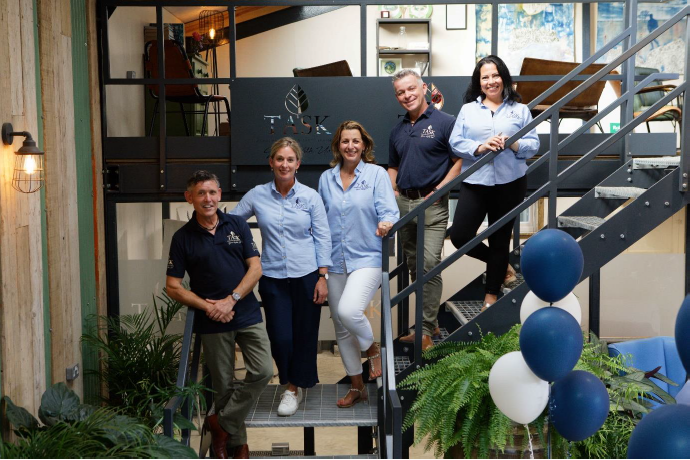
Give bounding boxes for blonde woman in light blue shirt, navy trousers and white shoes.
[230,137,331,416]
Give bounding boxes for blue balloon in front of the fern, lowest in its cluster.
[549,371,609,441]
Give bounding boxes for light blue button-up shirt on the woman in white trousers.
[319,161,400,273]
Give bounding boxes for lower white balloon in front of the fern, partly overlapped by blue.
[489,351,549,425]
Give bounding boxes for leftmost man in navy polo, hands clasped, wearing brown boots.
[166,171,273,458]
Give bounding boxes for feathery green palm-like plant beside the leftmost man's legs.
[82,289,205,429]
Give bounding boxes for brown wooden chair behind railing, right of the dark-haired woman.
[516,58,606,133]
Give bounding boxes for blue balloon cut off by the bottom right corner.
[628,404,690,458]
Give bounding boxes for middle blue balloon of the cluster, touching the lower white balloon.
[520,307,582,382]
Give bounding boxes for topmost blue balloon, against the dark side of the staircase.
[520,229,585,302]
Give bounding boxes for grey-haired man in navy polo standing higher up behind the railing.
[388,70,462,350]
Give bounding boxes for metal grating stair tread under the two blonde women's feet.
[245,383,378,428]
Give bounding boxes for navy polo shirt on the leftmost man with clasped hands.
[167,211,262,334]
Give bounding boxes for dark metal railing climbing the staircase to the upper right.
[380,0,690,458]
